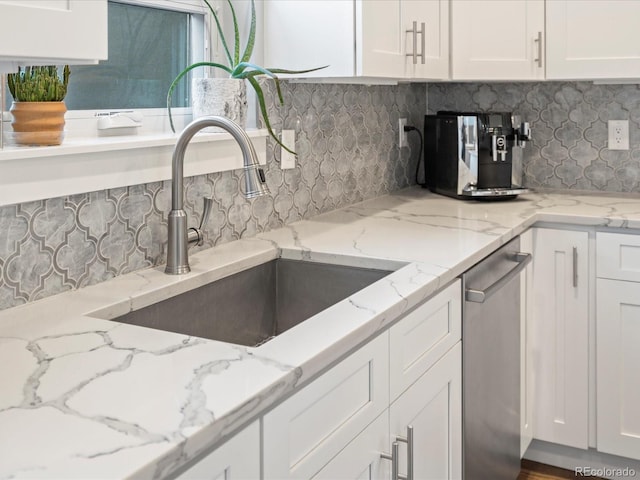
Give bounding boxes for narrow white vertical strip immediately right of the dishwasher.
[520,229,535,457]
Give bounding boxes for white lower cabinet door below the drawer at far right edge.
[596,278,640,460]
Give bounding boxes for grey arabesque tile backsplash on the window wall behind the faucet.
[0,82,426,309]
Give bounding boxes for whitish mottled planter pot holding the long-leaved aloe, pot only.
[191,78,247,132]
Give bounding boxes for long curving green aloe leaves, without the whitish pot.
[167,0,326,155]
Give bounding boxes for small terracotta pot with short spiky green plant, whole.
[7,65,71,146]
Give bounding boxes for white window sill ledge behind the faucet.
[0,128,268,206]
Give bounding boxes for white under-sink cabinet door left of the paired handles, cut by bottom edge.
[313,410,391,480]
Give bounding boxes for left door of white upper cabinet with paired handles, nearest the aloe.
[358,0,404,78]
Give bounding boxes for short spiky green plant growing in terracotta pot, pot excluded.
[7,65,71,102]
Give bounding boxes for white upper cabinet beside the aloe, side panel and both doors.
[264,0,448,80]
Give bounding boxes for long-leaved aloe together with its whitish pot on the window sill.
[167,0,325,154]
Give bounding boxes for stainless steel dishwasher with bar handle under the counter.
[462,237,531,480]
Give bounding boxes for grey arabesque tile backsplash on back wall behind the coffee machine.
[428,82,640,192]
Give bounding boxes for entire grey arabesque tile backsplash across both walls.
[0,82,640,309]
